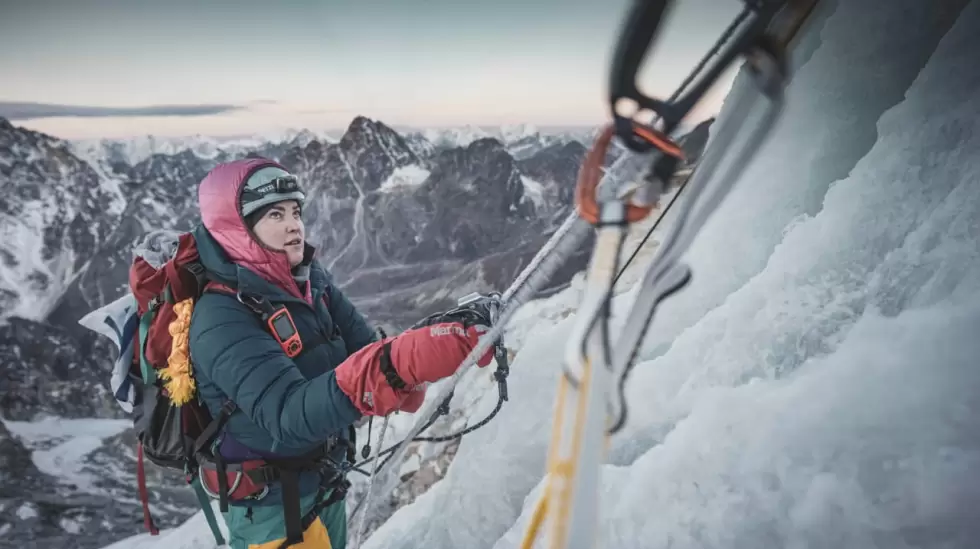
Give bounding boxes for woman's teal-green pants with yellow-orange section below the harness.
[222,494,347,549]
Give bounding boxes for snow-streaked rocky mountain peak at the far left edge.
[0,123,125,320]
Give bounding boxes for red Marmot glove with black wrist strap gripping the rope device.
[334,322,493,416]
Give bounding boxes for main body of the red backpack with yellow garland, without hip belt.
[129,229,235,545]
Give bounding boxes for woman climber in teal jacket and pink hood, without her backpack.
[189,158,492,549]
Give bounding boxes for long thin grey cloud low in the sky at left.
[0,101,244,120]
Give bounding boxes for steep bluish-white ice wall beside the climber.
[365,1,980,548]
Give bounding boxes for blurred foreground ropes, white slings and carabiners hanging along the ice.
[344,0,817,548]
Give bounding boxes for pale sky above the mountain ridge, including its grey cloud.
[0,0,742,138]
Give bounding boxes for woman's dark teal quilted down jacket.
[190,226,376,505]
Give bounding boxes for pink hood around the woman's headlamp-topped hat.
[197,158,309,300]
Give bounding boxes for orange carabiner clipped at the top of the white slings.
[575,122,684,225]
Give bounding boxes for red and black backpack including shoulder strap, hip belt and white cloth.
[79,227,354,545]
